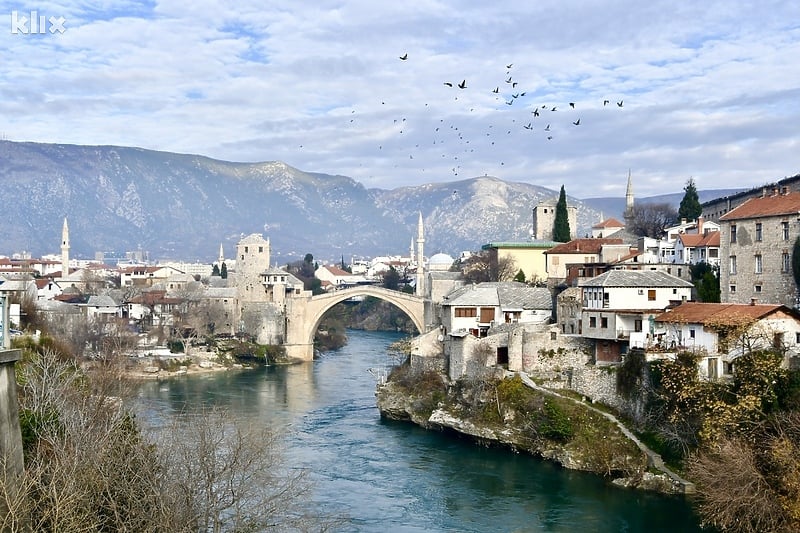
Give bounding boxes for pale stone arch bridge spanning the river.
[284,285,430,361]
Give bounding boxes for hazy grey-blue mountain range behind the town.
[0,141,744,264]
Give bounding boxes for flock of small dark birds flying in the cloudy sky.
[304,53,624,180]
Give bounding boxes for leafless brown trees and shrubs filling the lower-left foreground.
[0,344,336,533]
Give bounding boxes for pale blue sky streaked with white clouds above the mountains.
[0,0,800,198]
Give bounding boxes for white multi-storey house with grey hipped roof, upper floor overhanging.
[579,270,694,362]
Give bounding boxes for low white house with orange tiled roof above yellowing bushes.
[647,302,800,380]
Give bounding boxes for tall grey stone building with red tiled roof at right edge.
[720,189,800,307]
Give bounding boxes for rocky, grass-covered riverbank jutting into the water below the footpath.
[376,367,690,494]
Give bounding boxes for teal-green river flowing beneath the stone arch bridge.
[134,331,700,533]
